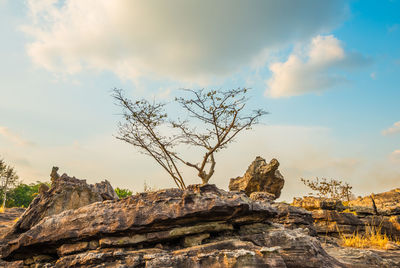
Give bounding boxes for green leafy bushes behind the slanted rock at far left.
[1,181,50,207]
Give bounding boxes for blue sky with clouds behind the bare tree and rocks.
[0,0,400,201]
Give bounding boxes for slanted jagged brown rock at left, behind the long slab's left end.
[5,174,118,239]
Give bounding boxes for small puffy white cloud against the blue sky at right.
[266,35,368,98]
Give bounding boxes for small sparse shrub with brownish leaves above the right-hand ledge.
[301,178,353,201]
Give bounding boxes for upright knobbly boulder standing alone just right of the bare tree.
[229,156,285,199]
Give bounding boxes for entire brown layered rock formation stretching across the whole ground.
[0,164,400,268]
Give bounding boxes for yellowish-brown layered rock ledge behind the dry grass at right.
[293,189,400,240]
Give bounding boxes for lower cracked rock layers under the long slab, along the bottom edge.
[50,226,344,268]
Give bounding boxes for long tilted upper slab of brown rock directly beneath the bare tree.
[3,185,276,257]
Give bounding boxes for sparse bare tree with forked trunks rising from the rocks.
[113,88,266,189]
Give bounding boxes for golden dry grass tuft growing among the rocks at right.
[340,225,400,250]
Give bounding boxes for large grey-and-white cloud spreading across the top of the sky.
[23,0,346,81]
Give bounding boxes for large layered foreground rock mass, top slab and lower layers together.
[2,185,344,268]
